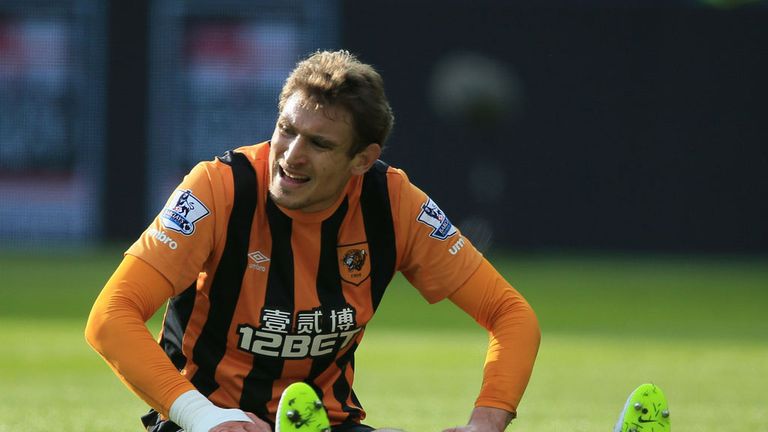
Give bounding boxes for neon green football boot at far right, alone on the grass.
[613,384,672,432]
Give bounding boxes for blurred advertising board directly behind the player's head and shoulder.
[147,0,339,215]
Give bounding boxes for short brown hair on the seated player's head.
[278,50,394,156]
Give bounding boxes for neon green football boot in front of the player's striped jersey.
[275,382,331,432]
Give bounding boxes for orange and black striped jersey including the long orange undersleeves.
[86,143,539,424]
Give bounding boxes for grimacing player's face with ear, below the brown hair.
[269,94,381,212]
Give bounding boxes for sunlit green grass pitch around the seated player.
[0,249,768,432]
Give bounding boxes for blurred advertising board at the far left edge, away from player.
[0,0,106,246]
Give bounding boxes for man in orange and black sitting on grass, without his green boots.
[86,51,540,432]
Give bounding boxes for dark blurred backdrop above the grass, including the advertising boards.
[0,0,768,254]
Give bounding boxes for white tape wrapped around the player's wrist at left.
[168,390,251,432]
